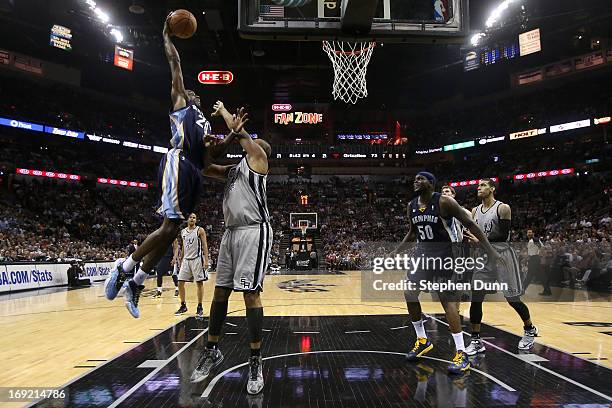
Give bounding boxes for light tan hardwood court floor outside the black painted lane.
[0,272,612,406]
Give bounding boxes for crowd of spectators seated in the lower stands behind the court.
[0,168,612,286]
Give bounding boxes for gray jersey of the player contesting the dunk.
[223,157,270,228]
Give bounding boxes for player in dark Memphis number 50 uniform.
[395,171,498,374]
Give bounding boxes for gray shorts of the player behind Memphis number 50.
[472,243,525,298]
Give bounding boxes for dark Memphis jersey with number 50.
[410,193,459,243]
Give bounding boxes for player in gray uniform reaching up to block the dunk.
[191,102,272,395]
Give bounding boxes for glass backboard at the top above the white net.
[238,0,469,43]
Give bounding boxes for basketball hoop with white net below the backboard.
[323,41,376,104]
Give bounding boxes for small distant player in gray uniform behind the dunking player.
[175,213,208,319]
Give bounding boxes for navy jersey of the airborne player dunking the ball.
[170,102,211,169]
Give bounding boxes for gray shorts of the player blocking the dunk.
[216,223,272,292]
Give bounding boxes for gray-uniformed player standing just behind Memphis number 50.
[466,179,538,355]
